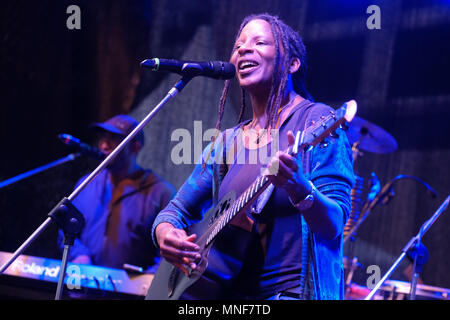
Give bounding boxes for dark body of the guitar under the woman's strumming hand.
[145,191,235,300]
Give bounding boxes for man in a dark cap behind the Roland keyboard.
[61,115,175,269]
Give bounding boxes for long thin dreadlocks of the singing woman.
[203,13,313,168]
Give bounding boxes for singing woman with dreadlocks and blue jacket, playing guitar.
[152,14,354,299]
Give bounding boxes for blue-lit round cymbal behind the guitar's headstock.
[347,116,398,153]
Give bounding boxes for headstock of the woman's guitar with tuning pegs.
[292,100,358,155]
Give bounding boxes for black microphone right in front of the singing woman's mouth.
[141,58,236,80]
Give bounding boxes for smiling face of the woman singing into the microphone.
[231,19,276,93]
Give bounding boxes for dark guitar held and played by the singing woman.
[146,100,357,300]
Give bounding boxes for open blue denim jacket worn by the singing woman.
[152,103,354,300]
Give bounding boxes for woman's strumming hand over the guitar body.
[155,222,201,275]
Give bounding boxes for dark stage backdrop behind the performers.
[0,0,450,294]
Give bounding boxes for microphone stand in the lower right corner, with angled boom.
[364,195,450,300]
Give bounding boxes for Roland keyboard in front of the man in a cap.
[0,251,154,298]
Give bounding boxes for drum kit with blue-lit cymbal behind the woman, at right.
[343,116,450,300]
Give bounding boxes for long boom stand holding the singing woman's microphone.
[0,76,192,300]
